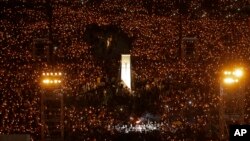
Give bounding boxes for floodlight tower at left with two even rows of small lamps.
[41,72,64,141]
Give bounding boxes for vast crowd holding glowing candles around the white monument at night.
[0,0,250,140]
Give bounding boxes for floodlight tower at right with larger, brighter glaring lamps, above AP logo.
[219,68,245,140]
